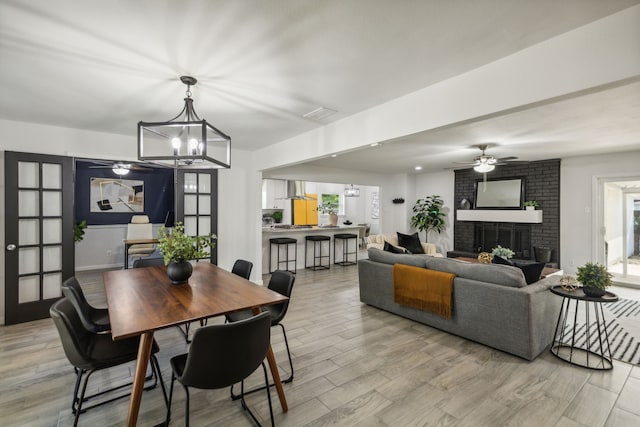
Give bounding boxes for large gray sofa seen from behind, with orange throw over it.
[358,248,562,360]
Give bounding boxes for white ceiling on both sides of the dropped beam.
[0,0,640,172]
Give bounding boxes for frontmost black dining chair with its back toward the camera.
[165,312,275,426]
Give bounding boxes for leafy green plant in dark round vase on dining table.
[158,222,217,285]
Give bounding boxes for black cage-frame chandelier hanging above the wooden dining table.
[138,76,231,169]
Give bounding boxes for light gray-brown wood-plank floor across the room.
[0,260,640,427]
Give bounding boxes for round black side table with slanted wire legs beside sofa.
[550,286,618,370]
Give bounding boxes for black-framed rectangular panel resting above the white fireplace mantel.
[473,178,524,209]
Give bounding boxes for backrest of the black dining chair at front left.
[49,298,94,369]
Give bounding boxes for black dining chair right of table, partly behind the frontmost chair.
[226,270,296,399]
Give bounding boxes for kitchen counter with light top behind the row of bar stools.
[262,224,364,274]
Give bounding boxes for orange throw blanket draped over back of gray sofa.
[393,264,456,319]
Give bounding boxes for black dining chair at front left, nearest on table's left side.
[49,298,167,427]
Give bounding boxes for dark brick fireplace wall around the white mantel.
[453,159,560,265]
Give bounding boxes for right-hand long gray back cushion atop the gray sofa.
[425,257,527,288]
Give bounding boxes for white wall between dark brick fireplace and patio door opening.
[560,150,640,274]
